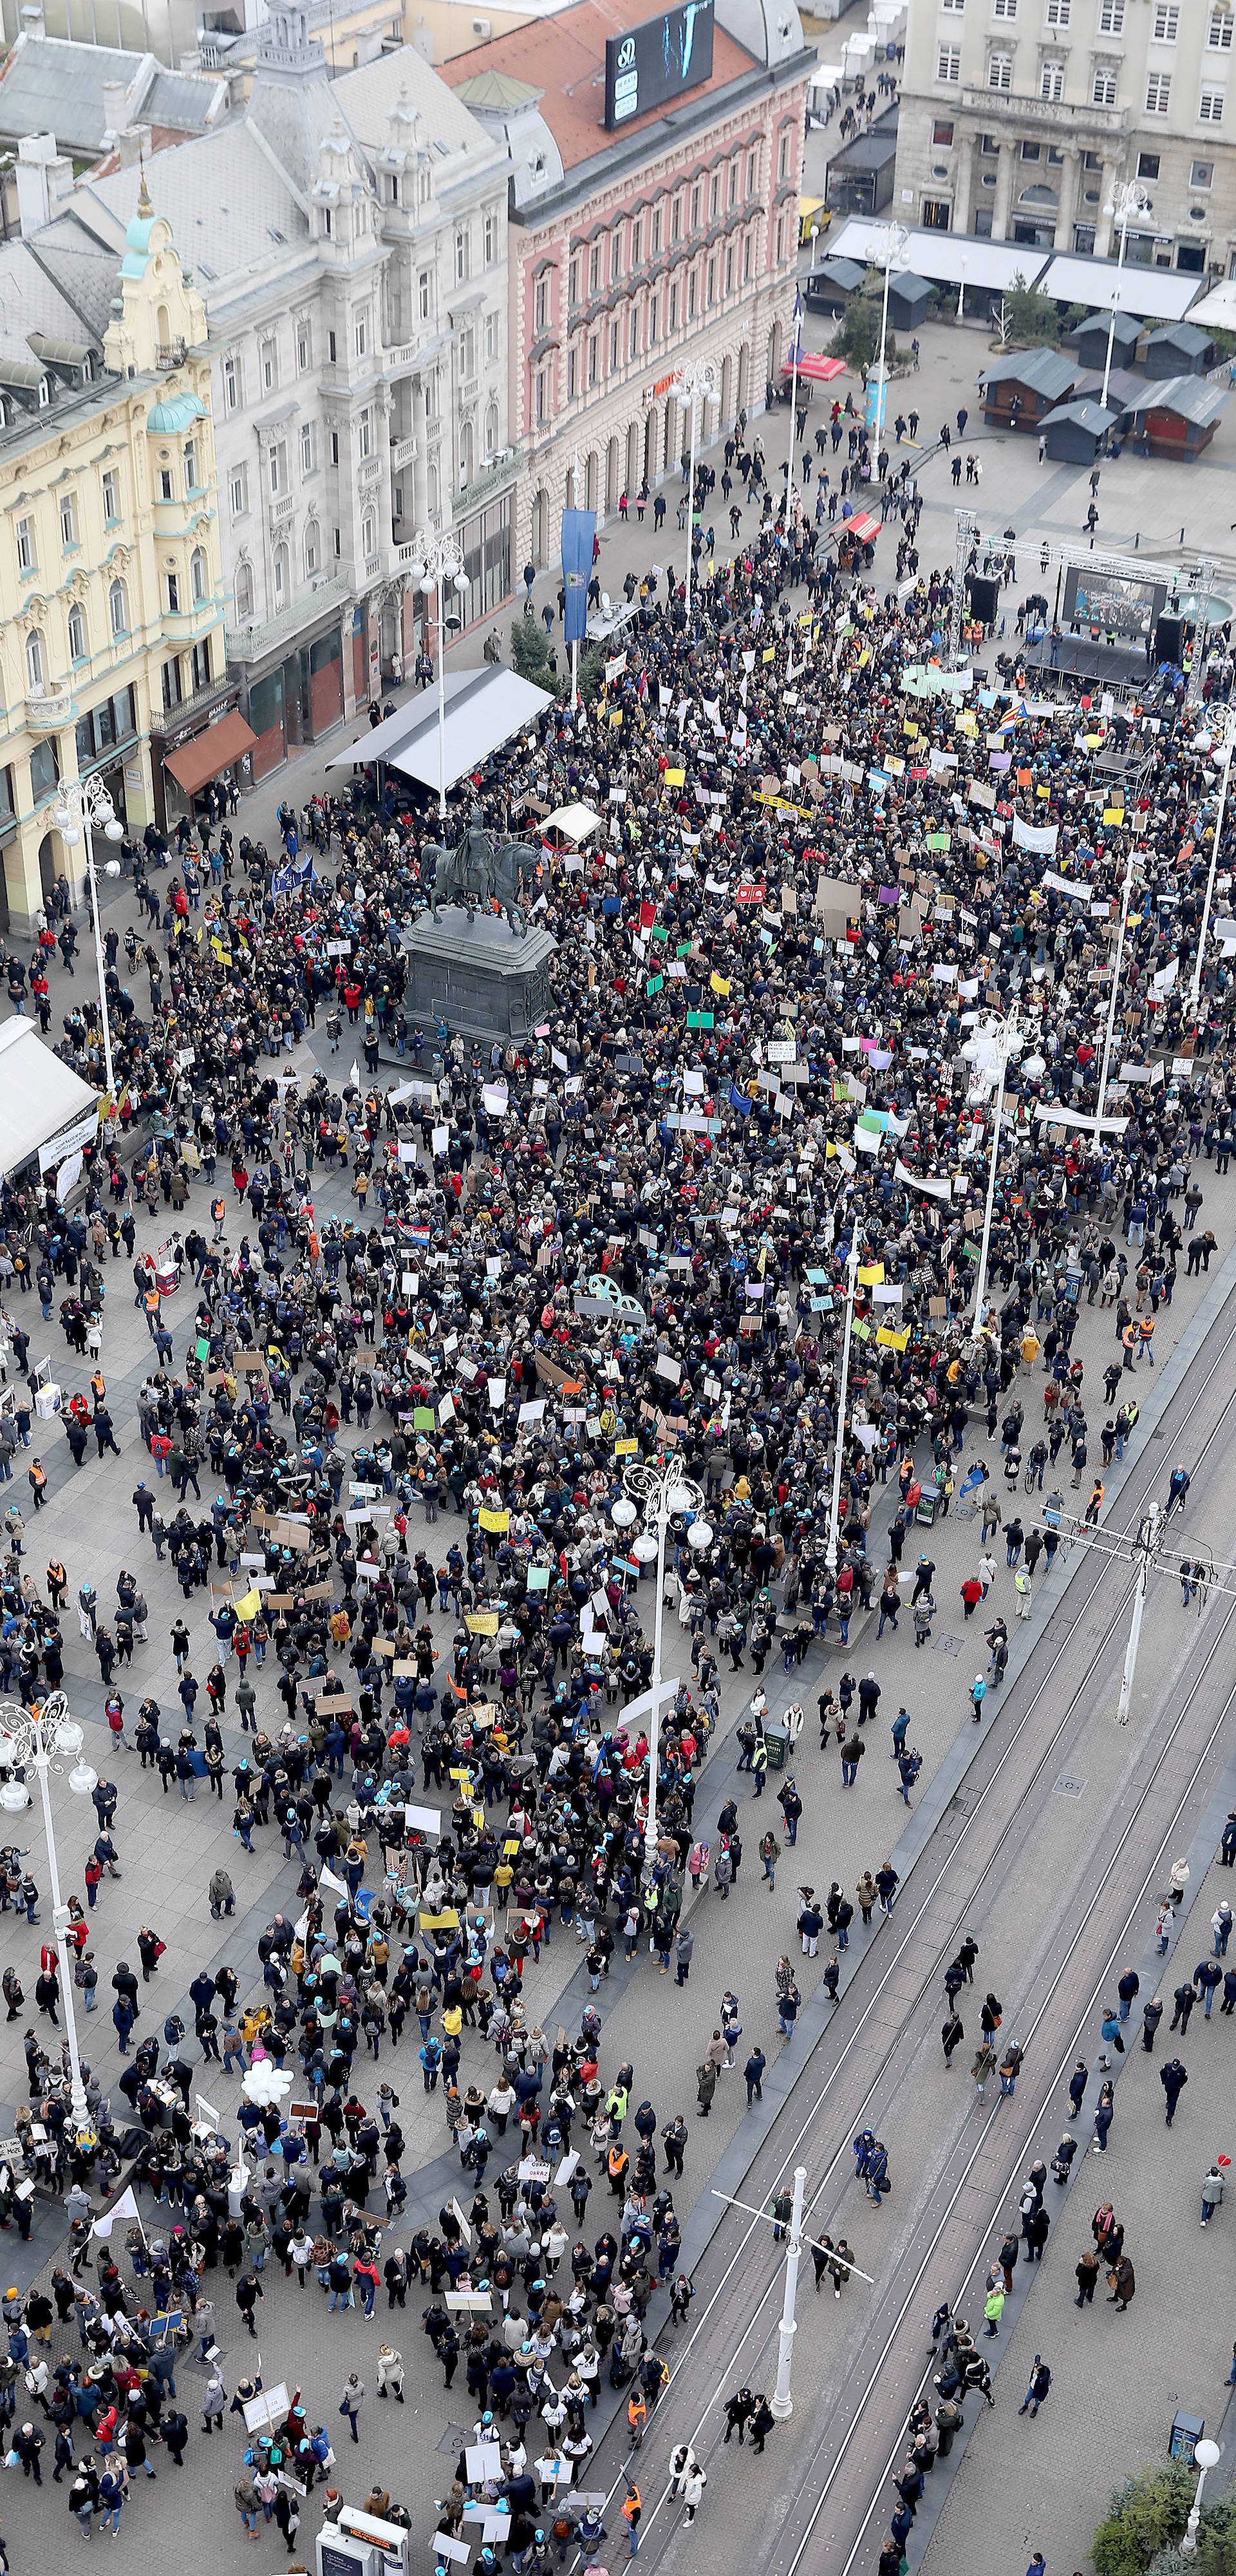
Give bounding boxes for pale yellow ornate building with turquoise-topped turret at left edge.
[0,188,234,933]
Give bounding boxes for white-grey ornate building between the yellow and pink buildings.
[15,8,518,781]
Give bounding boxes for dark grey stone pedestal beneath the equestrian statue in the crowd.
[404,904,559,1038]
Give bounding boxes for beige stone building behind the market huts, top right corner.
[896,0,1236,276]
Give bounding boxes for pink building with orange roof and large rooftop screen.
[440,0,814,567]
